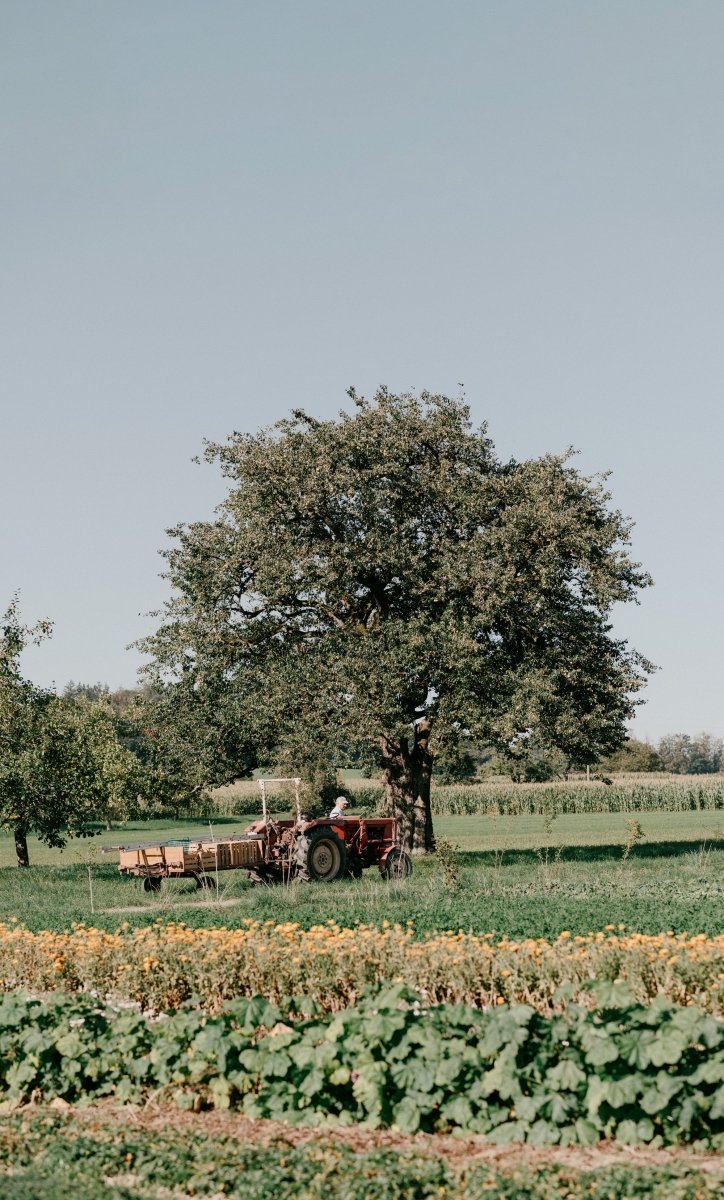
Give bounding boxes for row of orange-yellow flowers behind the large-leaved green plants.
[0,919,724,1014]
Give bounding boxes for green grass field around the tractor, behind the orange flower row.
[0,811,724,937]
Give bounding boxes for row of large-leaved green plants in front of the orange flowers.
[0,984,724,1148]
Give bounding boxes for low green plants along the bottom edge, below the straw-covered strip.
[0,1112,722,1200]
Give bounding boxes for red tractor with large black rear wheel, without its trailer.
[244,779,412,883]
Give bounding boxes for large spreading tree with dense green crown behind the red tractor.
[144,389,650,850]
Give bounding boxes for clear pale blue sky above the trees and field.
[0,0,724,738]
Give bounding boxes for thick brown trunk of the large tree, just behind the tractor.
[381,719,435,853]
